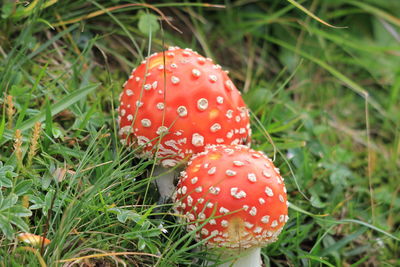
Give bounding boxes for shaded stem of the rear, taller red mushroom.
[153,166,175,204]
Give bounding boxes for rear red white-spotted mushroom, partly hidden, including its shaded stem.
[118,47,251,202]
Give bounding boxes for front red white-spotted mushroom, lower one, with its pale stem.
[173,145,289,267]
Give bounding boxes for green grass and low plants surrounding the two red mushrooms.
[0,0,400,266]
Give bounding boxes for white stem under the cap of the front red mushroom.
[208,247,262,267]
